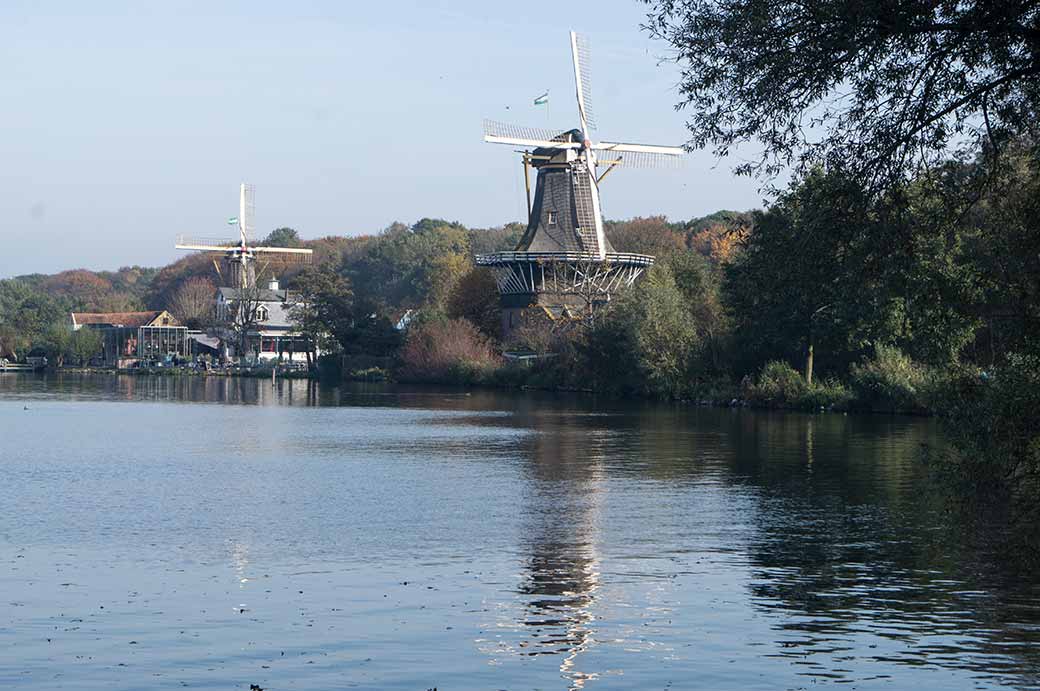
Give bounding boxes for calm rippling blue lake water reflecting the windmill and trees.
[0,374,1040,691]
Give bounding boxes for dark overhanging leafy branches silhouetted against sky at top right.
[644,0,1040,182]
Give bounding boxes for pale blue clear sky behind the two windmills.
[0,0,760,277]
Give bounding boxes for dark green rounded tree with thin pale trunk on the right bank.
[726,171,889,383]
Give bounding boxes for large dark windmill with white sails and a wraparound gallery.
[476,31,683,336]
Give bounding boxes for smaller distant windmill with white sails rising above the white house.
[175,182,314,289]
